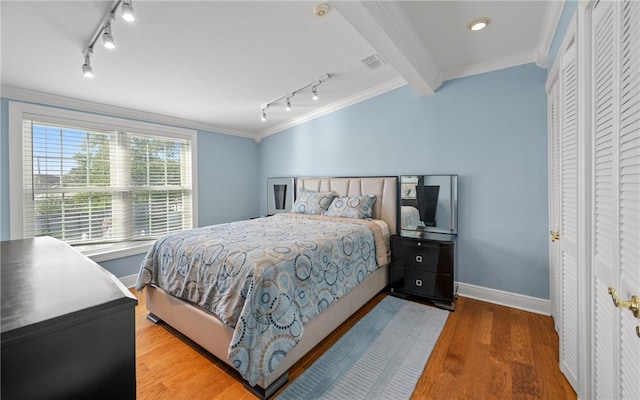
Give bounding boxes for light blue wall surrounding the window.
[0,98,266,277]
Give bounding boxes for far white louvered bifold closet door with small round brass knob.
[547,18,585,392]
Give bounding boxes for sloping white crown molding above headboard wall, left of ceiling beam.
[256,77,407,142]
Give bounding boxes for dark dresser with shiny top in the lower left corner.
[0,237,138,400]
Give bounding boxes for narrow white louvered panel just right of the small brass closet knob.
[558,46,579,388]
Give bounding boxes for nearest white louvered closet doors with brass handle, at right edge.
[592,0,640,400]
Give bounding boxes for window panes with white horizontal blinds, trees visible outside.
[25,121,192,244]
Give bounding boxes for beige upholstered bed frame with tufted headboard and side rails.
[146,176,398,398]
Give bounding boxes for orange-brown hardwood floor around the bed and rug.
[132,290,576,400]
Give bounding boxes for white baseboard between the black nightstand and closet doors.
[455,282,551,315]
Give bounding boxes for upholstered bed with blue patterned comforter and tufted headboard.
[136,177,398,398]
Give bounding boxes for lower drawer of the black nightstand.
[390,267,453,301]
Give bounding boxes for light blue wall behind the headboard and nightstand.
[259,64,549,299]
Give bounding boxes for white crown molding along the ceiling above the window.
[0,85,255,139]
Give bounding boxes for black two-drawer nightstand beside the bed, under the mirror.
[389,233,457,311]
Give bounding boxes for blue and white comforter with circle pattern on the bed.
[136,214,388,385]
